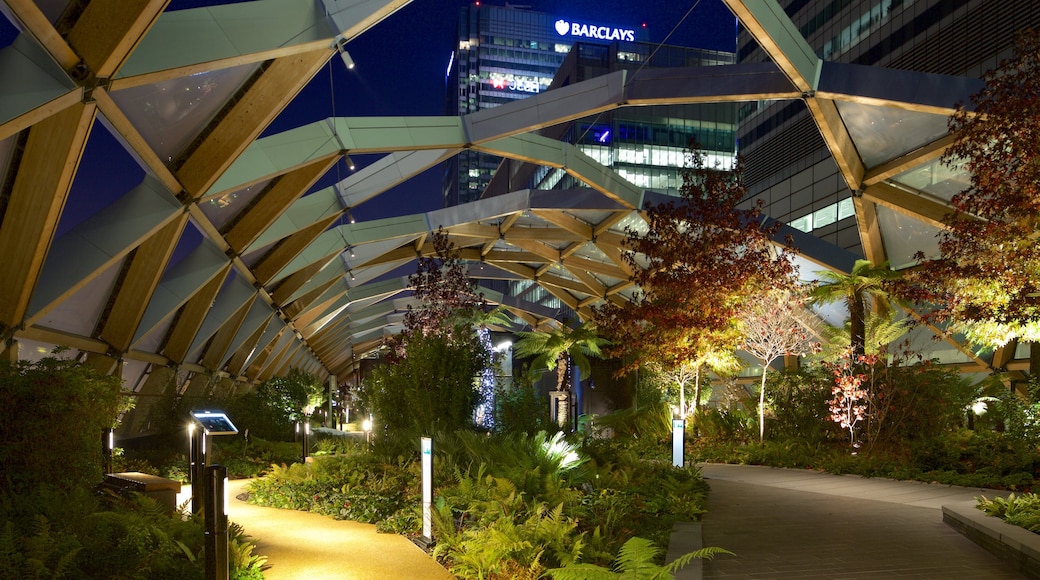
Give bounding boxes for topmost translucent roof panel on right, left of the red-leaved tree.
[836,101,946,167]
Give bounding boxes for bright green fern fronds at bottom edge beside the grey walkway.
[546,537,732,580]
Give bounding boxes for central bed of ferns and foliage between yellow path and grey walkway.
[250,430,707,579]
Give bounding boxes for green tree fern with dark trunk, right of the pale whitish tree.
[809,260,899,360]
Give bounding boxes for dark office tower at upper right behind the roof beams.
[737,0,1040,252]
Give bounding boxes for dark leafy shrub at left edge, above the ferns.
[0,357,125,497]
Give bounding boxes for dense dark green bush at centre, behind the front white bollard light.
[359,332,491,443]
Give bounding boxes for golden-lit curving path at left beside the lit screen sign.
[184,479,451,580]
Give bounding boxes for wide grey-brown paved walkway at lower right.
[699,464,1023,579]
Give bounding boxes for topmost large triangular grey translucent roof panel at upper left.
[112,62,260,163]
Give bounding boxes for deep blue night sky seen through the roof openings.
[0,0,736,229]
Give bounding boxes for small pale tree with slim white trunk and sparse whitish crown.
[740,290,820,441]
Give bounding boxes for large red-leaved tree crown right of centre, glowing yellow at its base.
[595,148,794,380]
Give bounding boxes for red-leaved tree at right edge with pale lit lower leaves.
[911,30,1040,346]
